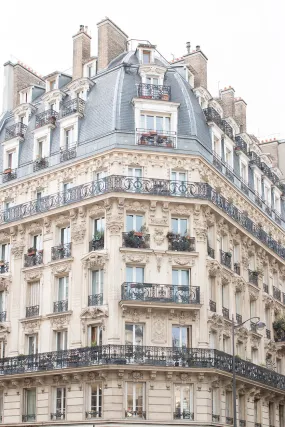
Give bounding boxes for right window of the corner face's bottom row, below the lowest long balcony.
[174,384,194,420]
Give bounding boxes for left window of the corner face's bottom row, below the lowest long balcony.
[125,382,145,418]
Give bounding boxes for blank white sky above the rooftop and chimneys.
[0,0,285,139]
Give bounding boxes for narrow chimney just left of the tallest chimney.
[72,25,91,80]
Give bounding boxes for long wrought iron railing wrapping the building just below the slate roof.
[0,175,285,259]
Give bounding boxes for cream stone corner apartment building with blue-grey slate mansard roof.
[0,18,285,427]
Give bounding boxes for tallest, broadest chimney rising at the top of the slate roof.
[97,18,128,71]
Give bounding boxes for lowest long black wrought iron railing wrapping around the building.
[0,344,285,390]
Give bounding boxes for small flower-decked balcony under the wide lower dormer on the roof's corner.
[137,129,176,148]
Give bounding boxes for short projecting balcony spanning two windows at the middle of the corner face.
[121,282,200,304]
